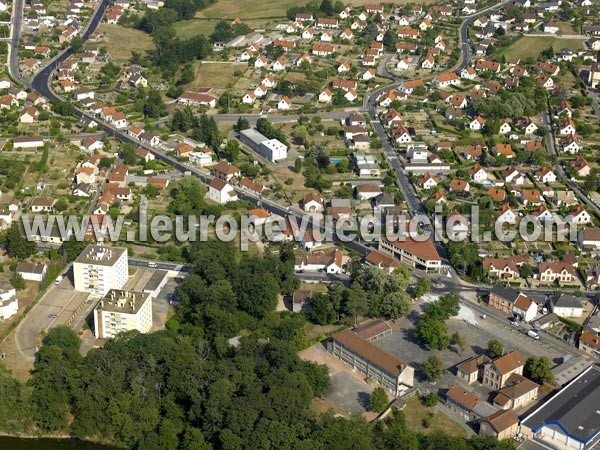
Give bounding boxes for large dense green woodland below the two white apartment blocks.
[0,242,512,450]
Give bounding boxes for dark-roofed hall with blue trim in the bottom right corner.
[521,365,600,450]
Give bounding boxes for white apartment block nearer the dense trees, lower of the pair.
[94,289,152,339]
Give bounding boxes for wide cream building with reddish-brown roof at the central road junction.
[379,236,442,273]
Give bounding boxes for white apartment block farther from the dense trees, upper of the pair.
[73,245,129,296]
